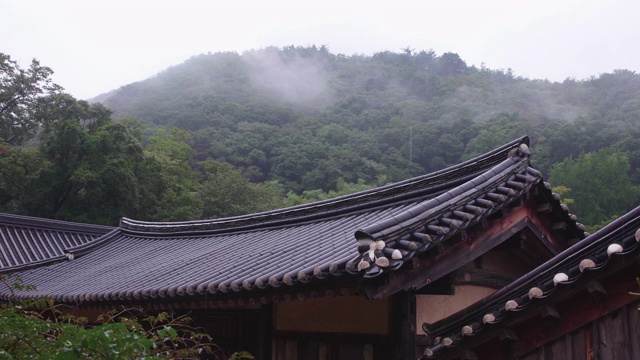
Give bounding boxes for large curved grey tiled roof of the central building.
[0,137,576,302]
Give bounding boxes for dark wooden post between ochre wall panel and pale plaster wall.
[389,291,416,360]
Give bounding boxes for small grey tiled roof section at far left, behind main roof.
[0,214,114,272]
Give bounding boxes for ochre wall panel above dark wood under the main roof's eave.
[271,296,390,360]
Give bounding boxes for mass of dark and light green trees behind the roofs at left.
[0,94,283,225]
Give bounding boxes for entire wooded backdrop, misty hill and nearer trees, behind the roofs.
[0,46,640,231]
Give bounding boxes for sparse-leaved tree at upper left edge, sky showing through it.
[0,53,62,145]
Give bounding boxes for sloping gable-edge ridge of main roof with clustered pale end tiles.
[347,152,542,277]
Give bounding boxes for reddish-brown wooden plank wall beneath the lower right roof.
[518,304,640,360]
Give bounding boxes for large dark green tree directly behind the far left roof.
[0,94,164,225]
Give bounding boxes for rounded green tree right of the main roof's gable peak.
[549,148,640,225]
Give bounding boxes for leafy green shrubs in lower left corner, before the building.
[0,275,253,360]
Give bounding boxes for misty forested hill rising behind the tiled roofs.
[102,46,640,183]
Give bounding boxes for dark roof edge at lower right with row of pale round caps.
[422,207,640,360]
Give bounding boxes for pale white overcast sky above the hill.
[0,0,640,99]
